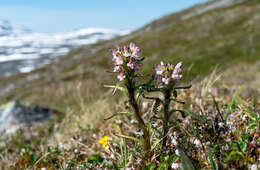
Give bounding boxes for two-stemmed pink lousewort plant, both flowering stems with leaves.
[106,43,191,167]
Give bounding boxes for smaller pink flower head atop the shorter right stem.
[154,61,182,86]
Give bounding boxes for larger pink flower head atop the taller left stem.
[110,42,142,81]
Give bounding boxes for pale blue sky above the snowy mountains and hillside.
[0,0,207,33]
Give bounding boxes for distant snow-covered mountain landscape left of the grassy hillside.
[0,20,129,76]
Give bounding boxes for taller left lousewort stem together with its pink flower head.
[107,43,151,161]
